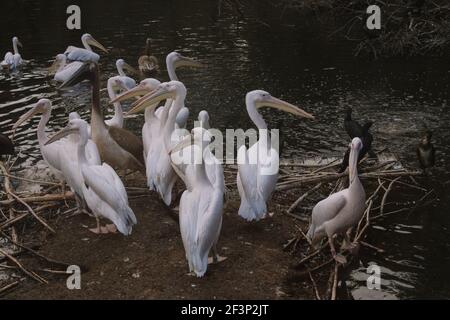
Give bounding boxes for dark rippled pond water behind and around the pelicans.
[0,0,450,298]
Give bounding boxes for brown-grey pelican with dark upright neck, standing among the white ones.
[60,62,144,171]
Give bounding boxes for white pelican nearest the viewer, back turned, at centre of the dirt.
[171,127,225,277]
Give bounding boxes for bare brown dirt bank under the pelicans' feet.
[3,174,313,299]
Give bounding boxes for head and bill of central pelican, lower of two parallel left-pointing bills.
[127,81,186,115]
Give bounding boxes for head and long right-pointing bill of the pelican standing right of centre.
[246,90,314,119]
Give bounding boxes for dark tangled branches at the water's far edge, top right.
[281,0,450,58]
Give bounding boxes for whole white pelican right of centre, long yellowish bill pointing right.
[237,90,314,221]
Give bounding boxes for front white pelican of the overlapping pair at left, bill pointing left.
[46,119,137,235]
